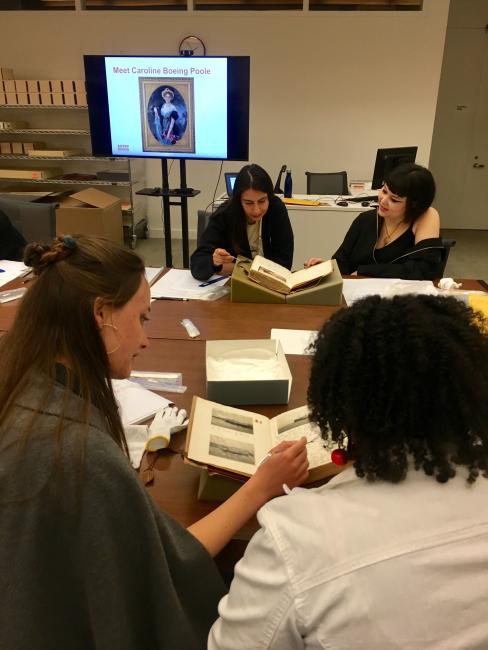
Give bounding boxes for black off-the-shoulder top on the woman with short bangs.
[333,210,444,280]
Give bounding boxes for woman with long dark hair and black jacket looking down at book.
[190,165,293,280]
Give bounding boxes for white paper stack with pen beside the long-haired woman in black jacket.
[151,269,229,300]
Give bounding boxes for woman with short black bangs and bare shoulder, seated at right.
[305,163,444,280]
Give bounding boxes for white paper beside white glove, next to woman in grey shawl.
[112,379,171,426]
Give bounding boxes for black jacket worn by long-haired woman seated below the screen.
[190,196,293,281]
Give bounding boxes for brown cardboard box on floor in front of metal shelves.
[56,188,123,243]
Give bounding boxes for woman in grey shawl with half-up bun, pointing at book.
[0,236,307,650]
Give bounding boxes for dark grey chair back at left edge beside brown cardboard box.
[0,197,58,243]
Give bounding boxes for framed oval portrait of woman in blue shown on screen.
[139,77,195,153]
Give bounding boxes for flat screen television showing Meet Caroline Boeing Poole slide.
[84,55,250,160]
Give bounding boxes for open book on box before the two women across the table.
[249,255,333,294]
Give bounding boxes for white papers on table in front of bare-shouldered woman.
[342,278,439,306]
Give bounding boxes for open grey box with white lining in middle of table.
[205,339,292,406]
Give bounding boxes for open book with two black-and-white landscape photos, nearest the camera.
[185,397,338,483]
